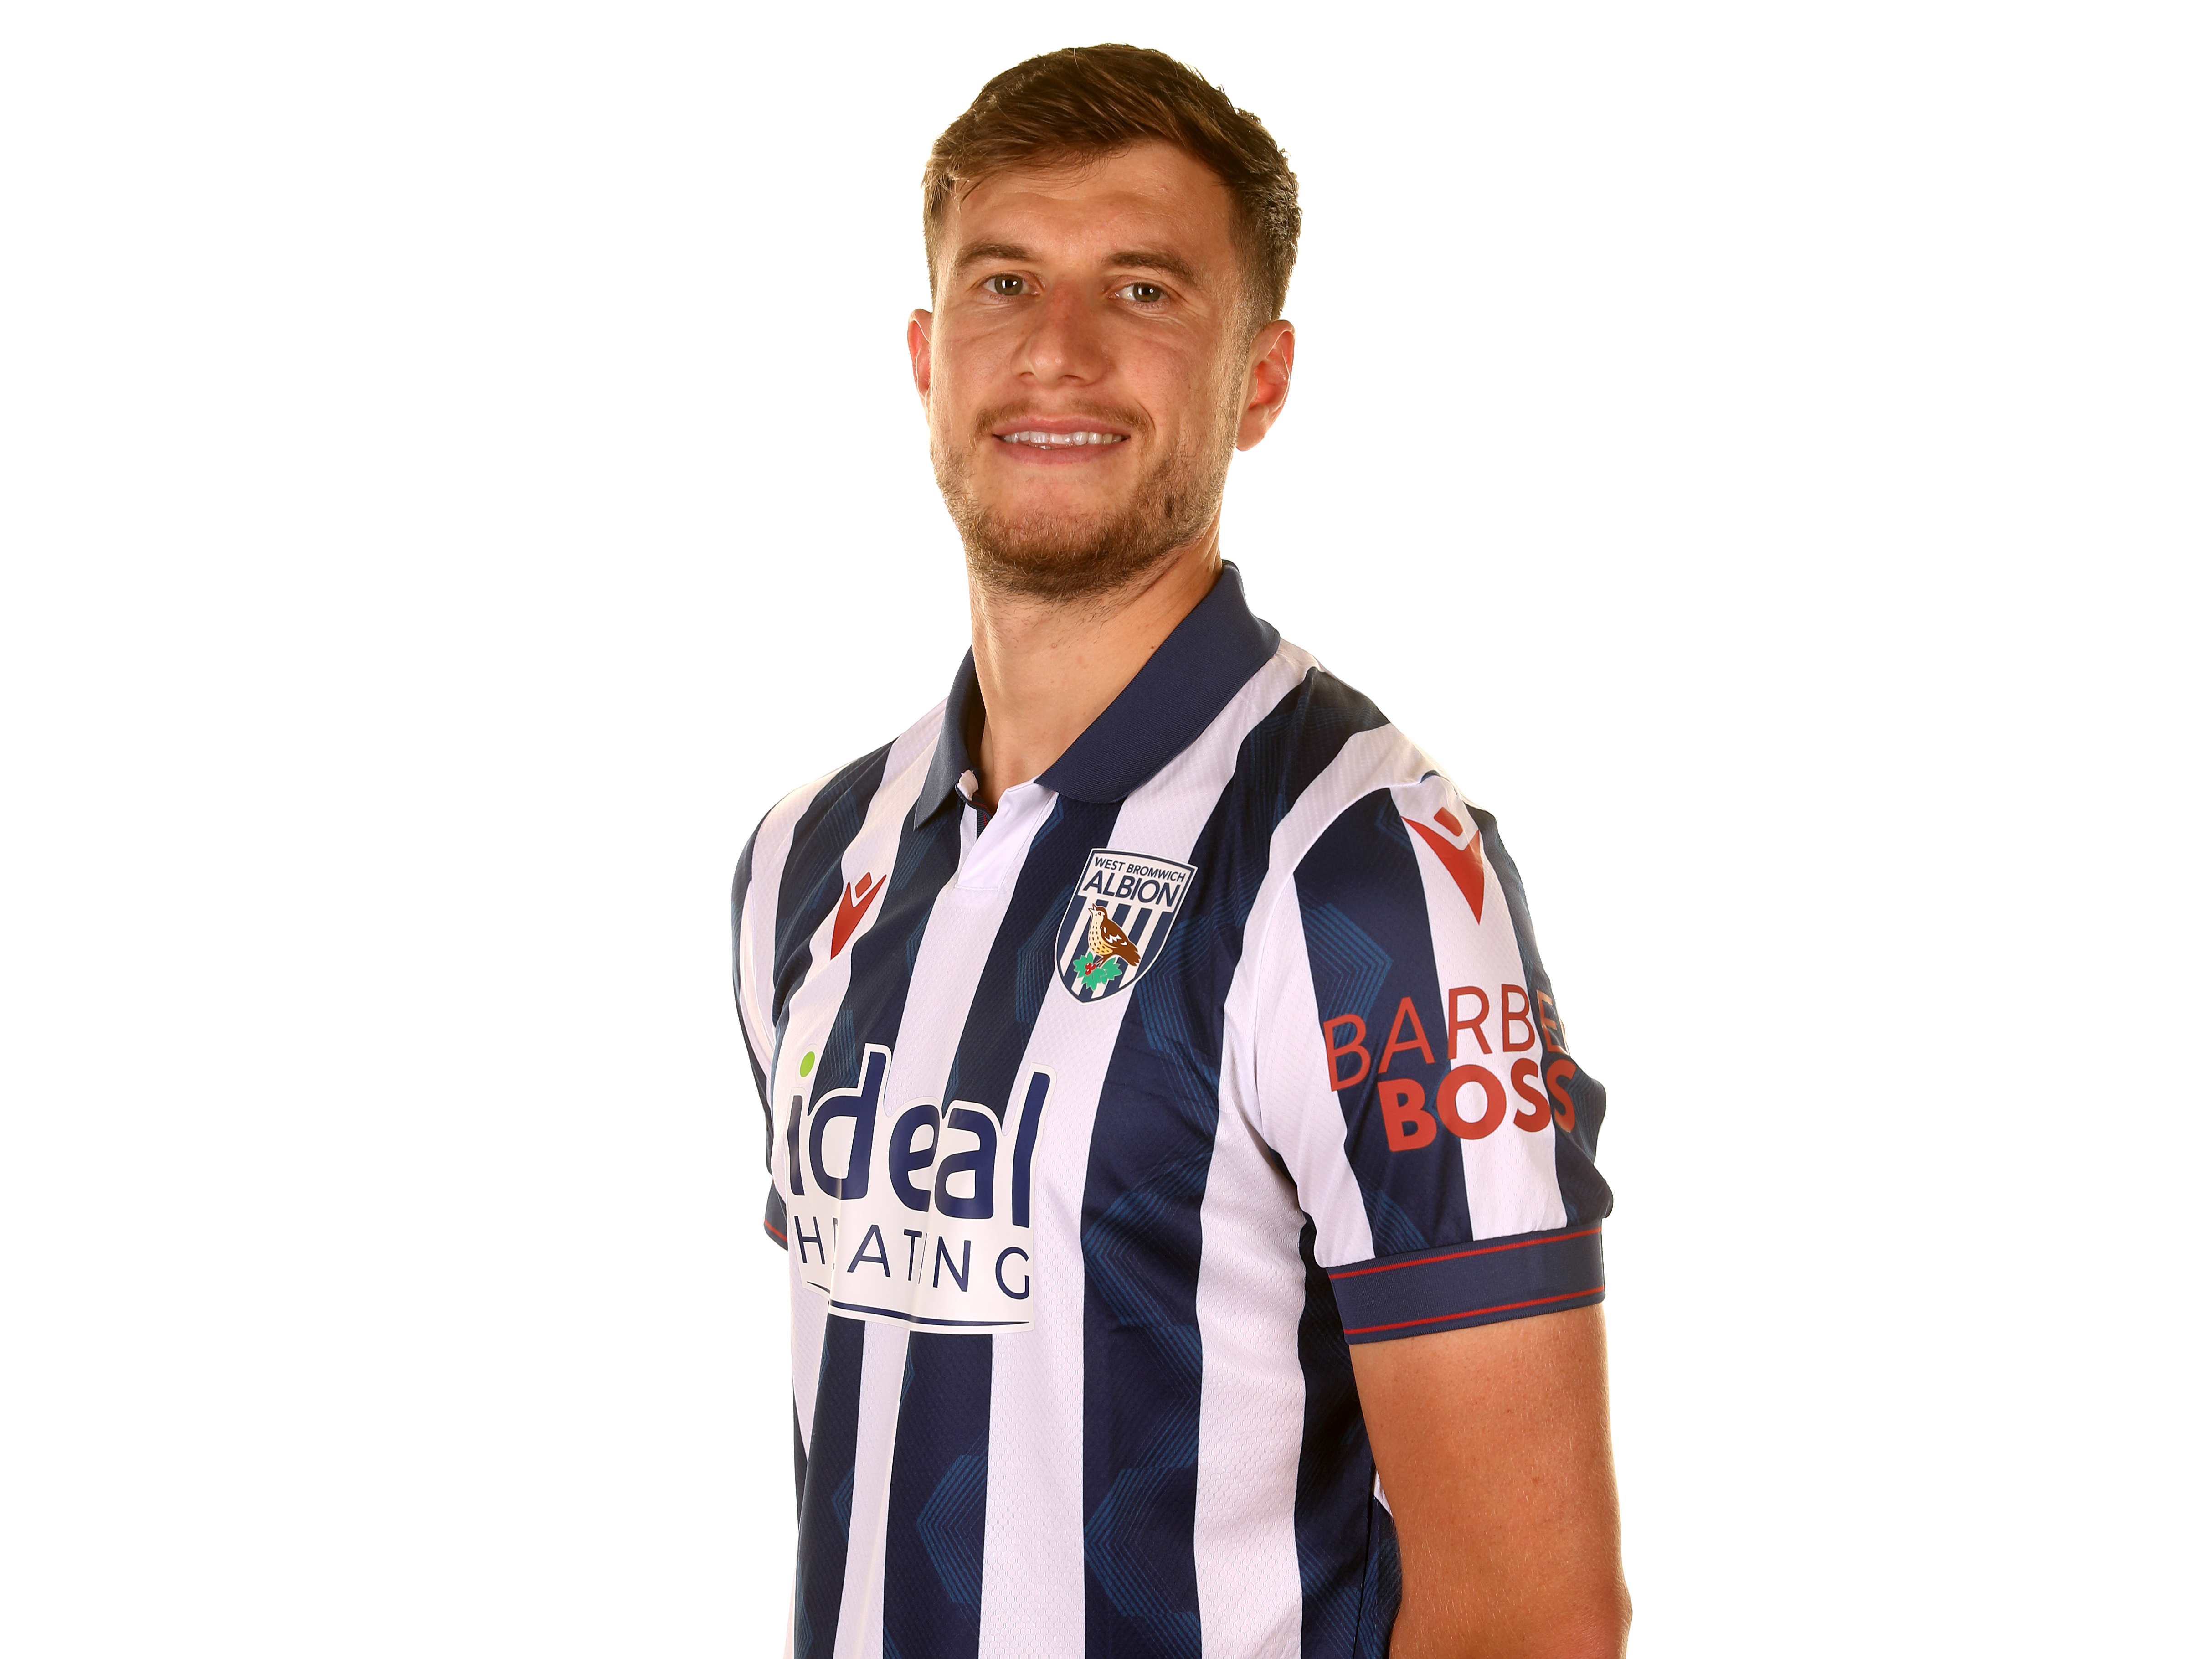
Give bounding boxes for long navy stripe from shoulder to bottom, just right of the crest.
[1082,675,1383,1659]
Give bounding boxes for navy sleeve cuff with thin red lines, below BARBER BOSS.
[1329,1221,1606,1343]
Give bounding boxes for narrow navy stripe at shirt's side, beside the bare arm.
[1292,1216,1376,1659]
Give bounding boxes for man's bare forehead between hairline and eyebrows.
[940,142,1236,272]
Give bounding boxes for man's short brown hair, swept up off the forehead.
[922,46,1298,321]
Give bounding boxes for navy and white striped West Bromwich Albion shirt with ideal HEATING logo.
[732,566,1613,1659]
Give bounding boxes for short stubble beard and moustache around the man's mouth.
[931,393,1236,602]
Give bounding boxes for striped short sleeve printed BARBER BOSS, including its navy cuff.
[1256,772,1613,1343]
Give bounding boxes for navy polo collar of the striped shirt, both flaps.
[914,560,1283,830]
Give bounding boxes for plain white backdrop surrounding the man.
[0,0,2212,1657]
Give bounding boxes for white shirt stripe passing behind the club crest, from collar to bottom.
[977,650,1310,1659]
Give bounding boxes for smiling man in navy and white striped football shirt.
[732,46,1628,1659]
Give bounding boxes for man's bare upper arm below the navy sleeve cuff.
[1352,1307,1628,1659]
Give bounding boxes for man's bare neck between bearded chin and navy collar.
[969,515,1221,812]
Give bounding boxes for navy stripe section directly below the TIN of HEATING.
[883,1332,991,1659]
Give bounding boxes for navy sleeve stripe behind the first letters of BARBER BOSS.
[1298,790,1473,1257]
